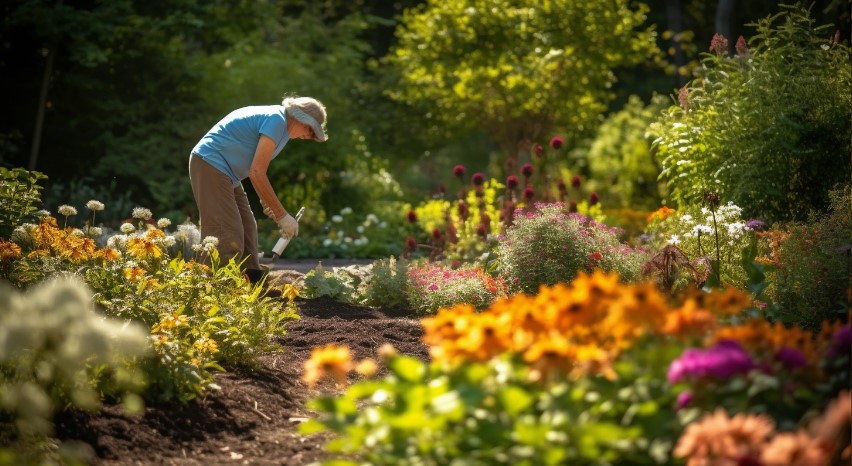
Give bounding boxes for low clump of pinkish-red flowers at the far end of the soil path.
[405,263,506,314]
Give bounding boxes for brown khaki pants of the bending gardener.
[189,154,260,270]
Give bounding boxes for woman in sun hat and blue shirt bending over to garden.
[189,97,328,283]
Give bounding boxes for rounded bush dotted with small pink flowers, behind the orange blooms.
[497,203,648,293]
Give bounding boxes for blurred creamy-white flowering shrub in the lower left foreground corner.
[0,275,150,464]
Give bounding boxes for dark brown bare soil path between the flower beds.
[51,271,428,466]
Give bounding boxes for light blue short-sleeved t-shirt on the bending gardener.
[192,105,290,187]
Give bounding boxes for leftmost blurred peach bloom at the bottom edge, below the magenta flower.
[673,408,775,466]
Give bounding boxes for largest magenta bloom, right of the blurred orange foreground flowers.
[667,340,754,383]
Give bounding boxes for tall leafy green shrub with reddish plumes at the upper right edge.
[651,5,852,222]
